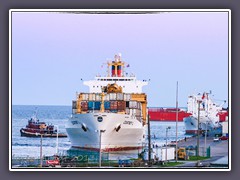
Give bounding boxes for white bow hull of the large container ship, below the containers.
[66,112,145,151]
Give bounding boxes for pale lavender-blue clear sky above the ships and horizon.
[11,12,229,107]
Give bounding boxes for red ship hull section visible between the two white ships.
[148,107,191,121]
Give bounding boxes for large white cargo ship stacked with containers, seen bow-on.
[66,54,148,152]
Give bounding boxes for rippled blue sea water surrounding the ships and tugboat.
[10,105,191,159]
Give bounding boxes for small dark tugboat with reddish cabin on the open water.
[20,114,67,138]
